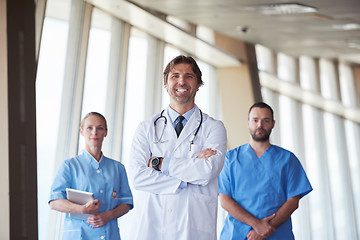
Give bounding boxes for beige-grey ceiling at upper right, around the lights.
[132,0,360,64]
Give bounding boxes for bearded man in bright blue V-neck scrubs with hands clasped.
[219,102,312,240]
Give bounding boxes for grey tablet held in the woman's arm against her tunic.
[66,188,94,220]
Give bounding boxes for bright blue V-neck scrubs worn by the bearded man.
[218,144,312,240]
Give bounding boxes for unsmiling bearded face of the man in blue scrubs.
[248,107,275,142]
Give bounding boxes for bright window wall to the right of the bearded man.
[256,46,360,239]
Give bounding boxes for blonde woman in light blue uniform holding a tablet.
[49,112,133,240]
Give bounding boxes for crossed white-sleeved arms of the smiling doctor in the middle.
[129,119,227,194]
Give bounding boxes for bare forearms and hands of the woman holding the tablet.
[50,199,130,228]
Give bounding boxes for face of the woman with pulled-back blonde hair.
[80,115,107,151]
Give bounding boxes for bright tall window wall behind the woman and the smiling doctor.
[36,0,231,240]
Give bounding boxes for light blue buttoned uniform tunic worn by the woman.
[49,151,133,240]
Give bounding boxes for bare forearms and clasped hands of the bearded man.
[219,193,300,240]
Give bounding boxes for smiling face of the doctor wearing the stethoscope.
[165,63,200,110]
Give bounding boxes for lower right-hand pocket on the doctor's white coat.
[190,192,217,232]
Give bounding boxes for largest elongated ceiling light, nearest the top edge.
[246,3,317,15]
